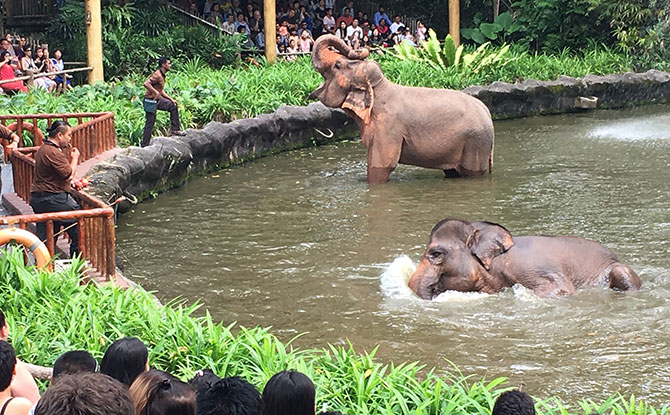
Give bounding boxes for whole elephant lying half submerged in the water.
[409,219,642,300]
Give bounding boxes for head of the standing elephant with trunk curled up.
[309,35,386,124]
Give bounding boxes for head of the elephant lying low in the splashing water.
[409,219,514,300]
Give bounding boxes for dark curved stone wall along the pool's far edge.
[88,70,670,211]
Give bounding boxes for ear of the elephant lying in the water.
[465,222,514,270]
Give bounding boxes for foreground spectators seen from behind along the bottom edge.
[0,311,608,415]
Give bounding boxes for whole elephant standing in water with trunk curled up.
[309,35,494,184]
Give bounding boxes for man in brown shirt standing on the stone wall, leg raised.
[141,56,184,147]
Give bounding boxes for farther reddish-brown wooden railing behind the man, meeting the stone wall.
[0,112,116,164]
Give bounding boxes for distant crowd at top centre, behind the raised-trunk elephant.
[183,0,427,59]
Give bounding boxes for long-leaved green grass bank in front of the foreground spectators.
[0,252,670,415]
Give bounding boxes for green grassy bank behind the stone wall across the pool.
[0,49,644,146]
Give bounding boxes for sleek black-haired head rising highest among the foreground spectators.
[100,337,149,387]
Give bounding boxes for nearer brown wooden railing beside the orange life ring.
[0,147,116,279]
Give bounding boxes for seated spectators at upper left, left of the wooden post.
[0,33,72,93]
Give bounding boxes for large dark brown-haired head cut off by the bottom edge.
[35,373,135,415]
